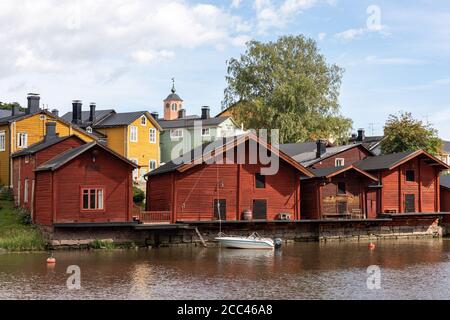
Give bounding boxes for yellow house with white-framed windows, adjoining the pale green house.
[63,101,161,183]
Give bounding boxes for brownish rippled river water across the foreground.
[0,240,450,299]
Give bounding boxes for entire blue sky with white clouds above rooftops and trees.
[0,0,450,140]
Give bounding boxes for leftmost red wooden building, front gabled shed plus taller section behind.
[14,121,136,227]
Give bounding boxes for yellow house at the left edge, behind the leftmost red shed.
[0,94,96,187]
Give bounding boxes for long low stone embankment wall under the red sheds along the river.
[50,216,442,248]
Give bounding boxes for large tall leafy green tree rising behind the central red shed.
[222,35,352,143]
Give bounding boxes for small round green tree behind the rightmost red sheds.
[381,112,442,155]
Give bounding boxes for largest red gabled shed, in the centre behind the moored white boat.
[147,134,312,222]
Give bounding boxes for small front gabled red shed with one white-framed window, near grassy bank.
[34,142,136,226]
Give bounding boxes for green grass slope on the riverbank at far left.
[0,192,47,251]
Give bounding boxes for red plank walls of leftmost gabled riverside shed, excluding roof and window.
[35,147,132,223]
